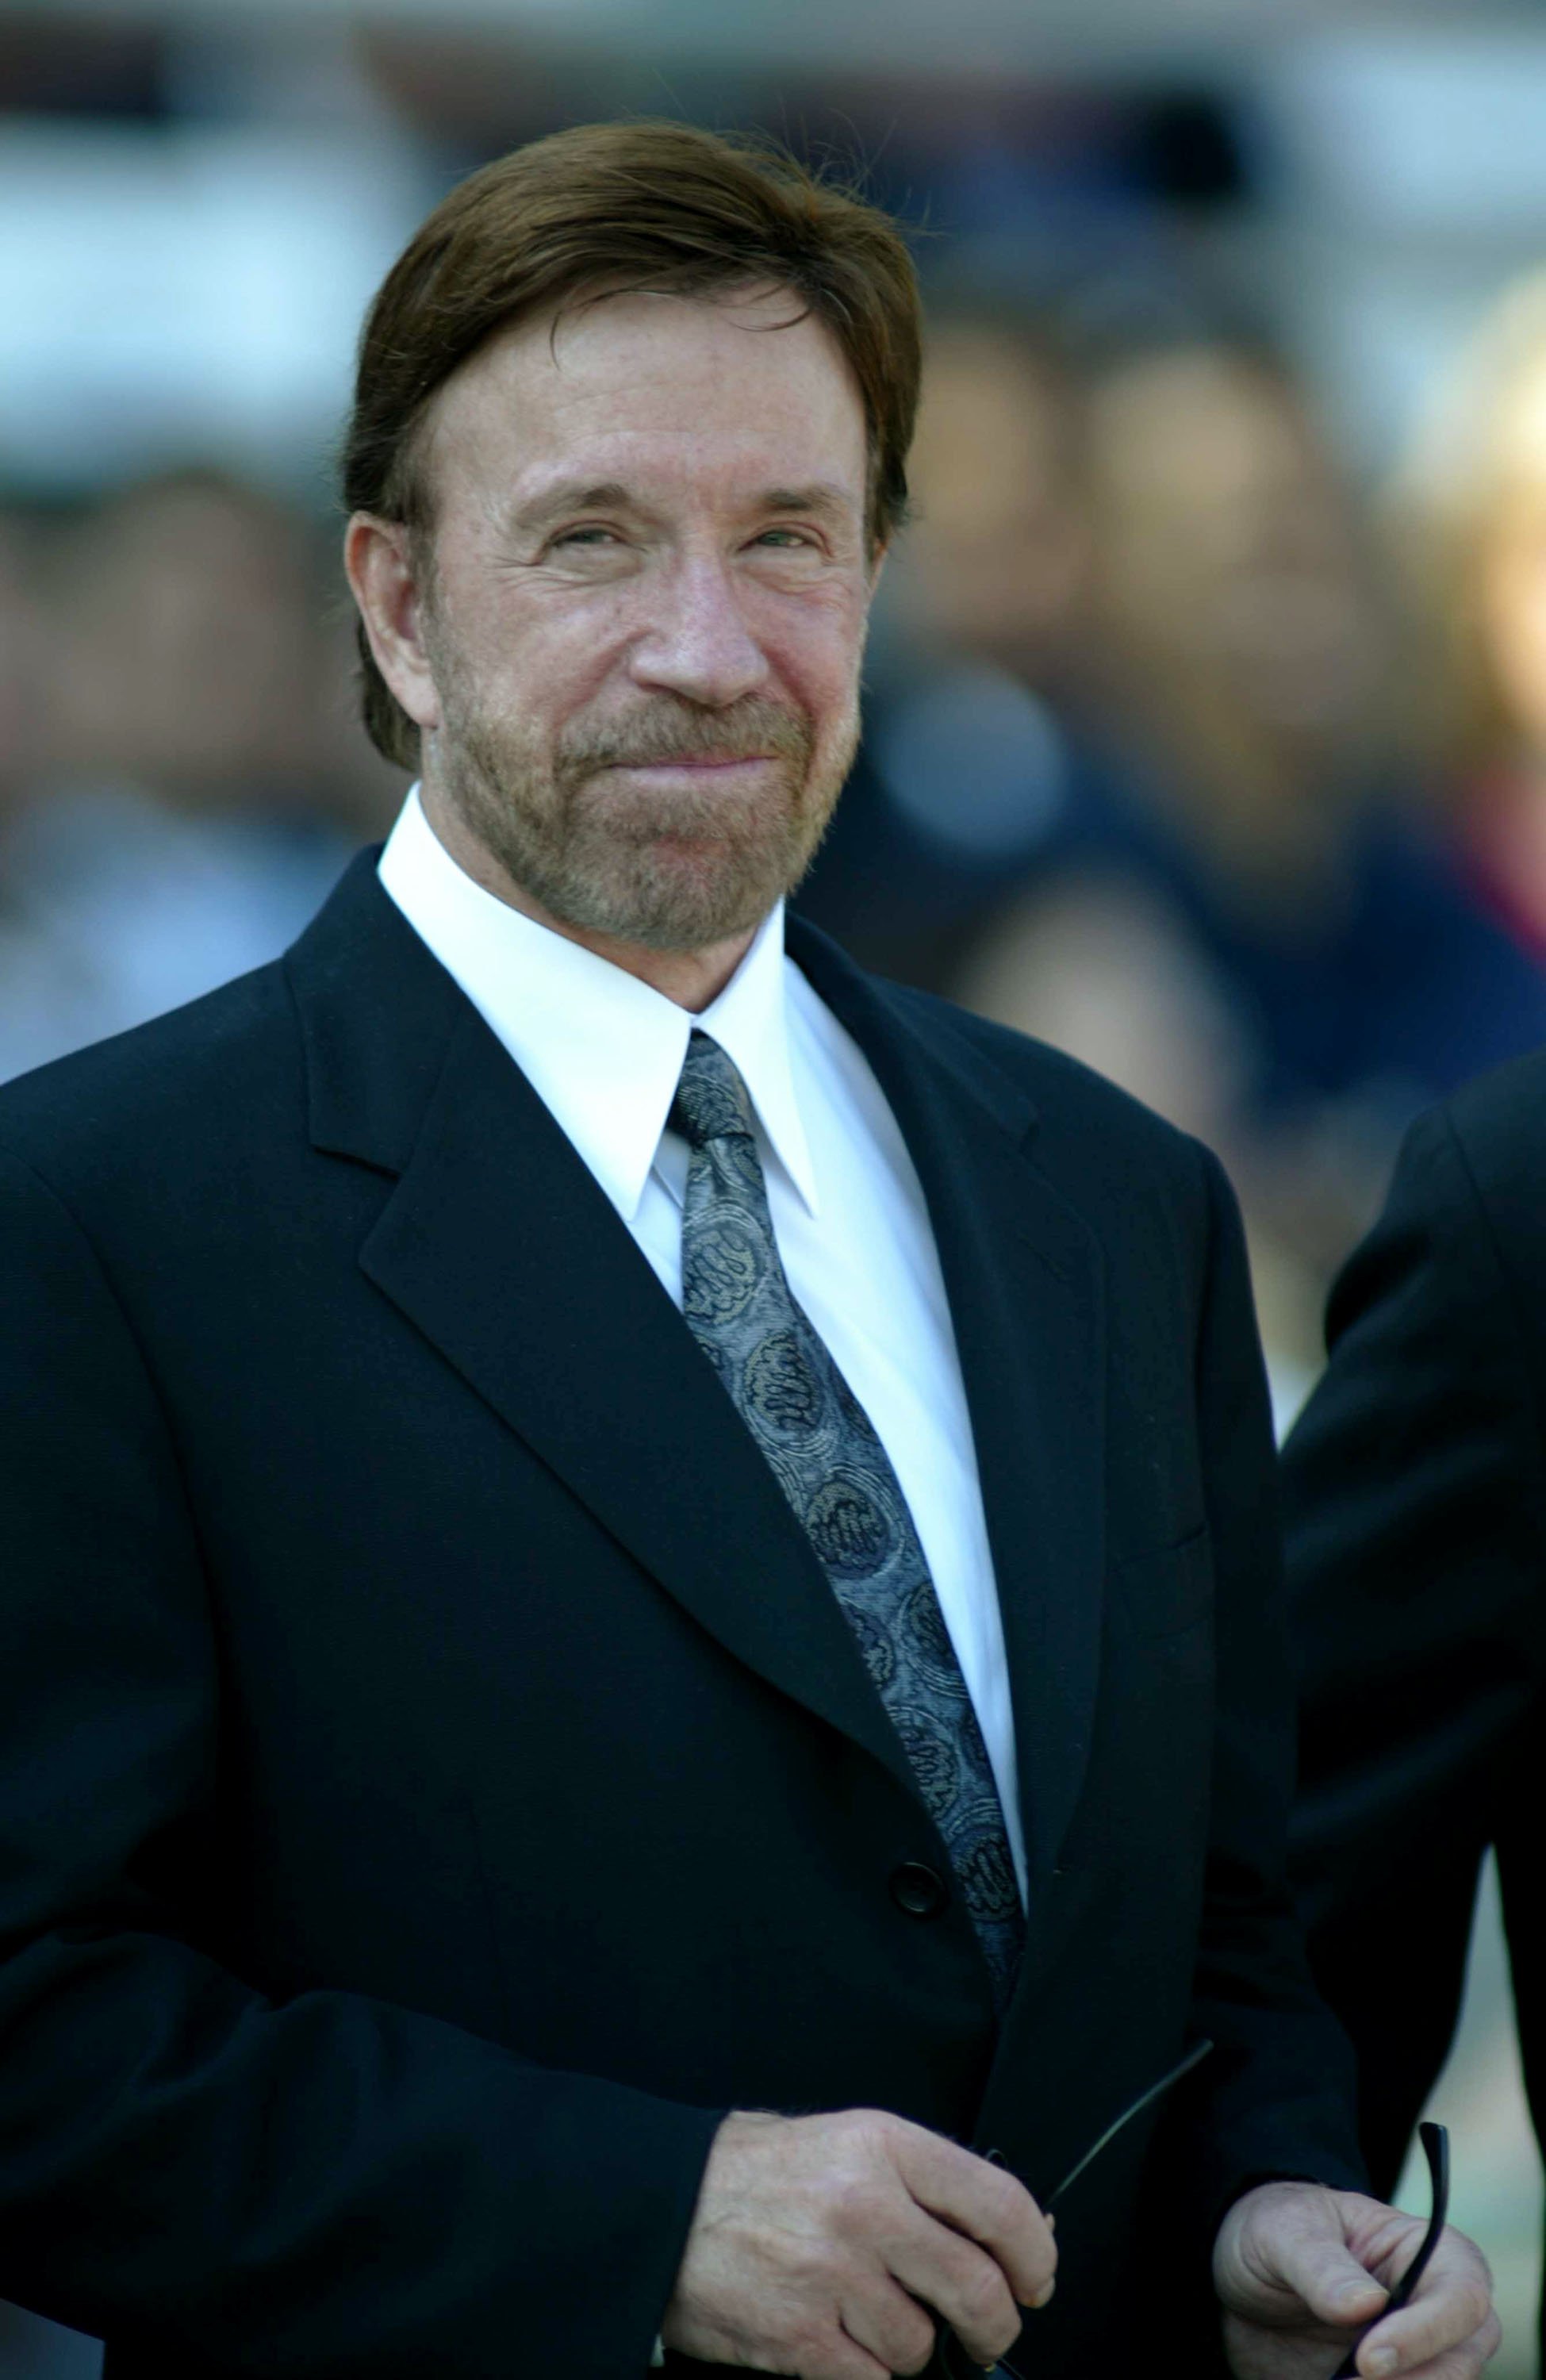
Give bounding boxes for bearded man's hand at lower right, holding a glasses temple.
[1213,2182,1501,2380]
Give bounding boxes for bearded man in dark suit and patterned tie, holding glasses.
[0,126,1496,2380]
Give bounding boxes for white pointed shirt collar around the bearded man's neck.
[381,785,815,1223]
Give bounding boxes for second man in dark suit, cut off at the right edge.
[1284,1057,1546,2361]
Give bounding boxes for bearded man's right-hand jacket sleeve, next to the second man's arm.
[1160,1157,1365,2244]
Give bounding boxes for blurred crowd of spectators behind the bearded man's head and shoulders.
[12,260,1546,1418]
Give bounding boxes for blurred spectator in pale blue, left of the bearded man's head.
[0,469,375,1076]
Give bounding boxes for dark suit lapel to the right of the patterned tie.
[789,921,1106,1916]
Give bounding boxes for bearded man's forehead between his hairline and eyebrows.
[428,290,865,507]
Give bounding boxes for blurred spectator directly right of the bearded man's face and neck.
[796,307,1113,990]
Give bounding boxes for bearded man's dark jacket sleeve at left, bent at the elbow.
[0,1157,719,2380]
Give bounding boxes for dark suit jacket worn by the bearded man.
[0,857,1358,2380]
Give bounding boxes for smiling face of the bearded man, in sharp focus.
[399,290,873,950]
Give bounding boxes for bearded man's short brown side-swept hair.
[343,121,920,769]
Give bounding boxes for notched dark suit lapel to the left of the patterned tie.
[359,1007,915,1792]
